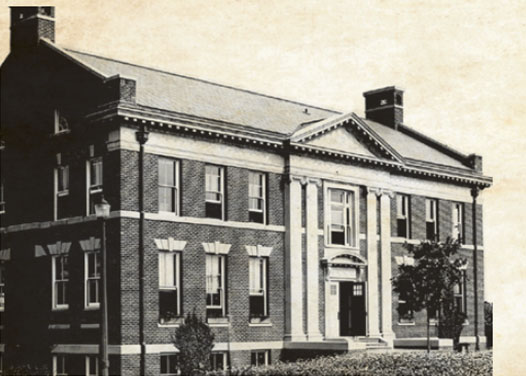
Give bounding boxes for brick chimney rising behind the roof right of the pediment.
[363,86,404,129]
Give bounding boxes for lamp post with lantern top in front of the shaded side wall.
[95,195,111,376]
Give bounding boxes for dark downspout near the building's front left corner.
[135,124,149,375]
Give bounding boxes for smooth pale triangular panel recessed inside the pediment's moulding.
[306,127,376,157]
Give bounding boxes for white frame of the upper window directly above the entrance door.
[324,183,360,250]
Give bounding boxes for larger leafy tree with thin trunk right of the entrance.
[393,237,466,352]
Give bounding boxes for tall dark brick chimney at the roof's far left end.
[10,7,55,52]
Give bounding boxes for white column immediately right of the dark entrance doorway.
[367,188,380,336]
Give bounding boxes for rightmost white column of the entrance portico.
[380,190,394,339]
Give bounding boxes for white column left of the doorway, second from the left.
[305,179,322,341]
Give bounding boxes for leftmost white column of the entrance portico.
[285,176,305,341]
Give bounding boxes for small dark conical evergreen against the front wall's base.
[172,312,214,375]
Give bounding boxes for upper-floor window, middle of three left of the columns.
[205,165,225,219]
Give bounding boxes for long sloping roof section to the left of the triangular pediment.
[66,49,337,134]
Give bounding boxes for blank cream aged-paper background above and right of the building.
[0,0,526,375]
